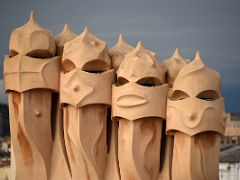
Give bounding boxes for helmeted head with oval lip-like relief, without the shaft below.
[112,43,168,120]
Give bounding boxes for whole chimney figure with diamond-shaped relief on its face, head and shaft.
[60,28,114,180]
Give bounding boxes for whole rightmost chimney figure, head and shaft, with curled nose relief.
[167,52,226,180]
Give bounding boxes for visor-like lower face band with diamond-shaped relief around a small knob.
[60,69,114,107]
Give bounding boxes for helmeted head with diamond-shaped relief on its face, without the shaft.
[60,28,114,107]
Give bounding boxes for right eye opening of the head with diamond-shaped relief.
[82,59,110,73]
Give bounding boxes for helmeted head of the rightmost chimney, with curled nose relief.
[167,54,226,136]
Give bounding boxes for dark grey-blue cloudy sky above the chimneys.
[0,0,240,112]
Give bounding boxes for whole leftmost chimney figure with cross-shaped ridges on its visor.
[4,12,60,180]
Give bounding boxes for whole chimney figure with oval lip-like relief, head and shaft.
[112,42,168,180]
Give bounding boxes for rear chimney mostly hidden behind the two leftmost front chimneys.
[49,24,77,180]
